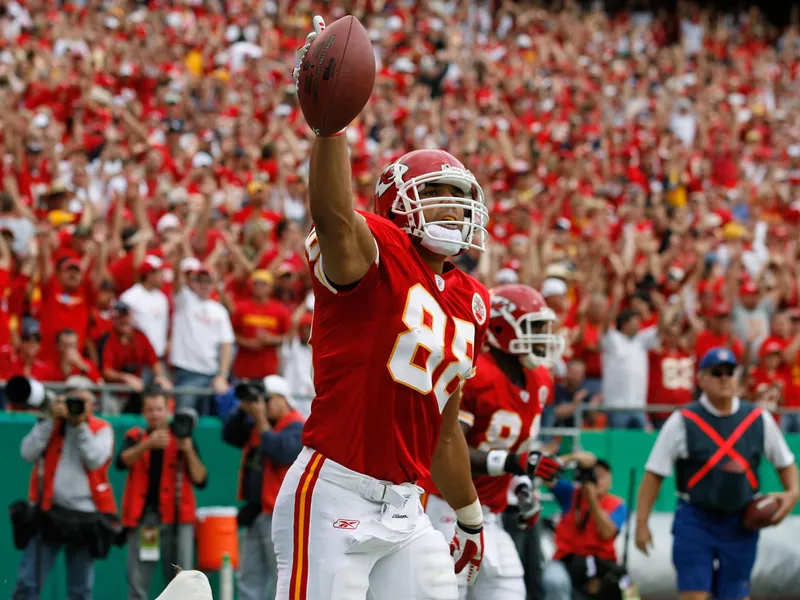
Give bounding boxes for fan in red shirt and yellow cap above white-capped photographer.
[232,270,291,379]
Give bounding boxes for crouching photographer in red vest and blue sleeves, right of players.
[544,452,628,600]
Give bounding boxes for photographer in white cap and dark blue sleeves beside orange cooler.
[222,375,305,600]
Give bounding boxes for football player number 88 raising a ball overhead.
[272,17,489,600]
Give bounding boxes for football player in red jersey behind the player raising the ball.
[421,284,565,600]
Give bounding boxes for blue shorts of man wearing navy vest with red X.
[672,501,758,600]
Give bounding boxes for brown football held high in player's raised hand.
[297,16,375,136]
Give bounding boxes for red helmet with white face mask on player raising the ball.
[375,150,489,256]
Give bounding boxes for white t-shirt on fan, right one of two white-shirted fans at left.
[169,287,236,375]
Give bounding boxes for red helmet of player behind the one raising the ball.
[487,284,566,368]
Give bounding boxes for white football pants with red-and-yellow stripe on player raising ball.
[272,448,458,600]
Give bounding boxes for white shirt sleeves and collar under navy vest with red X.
[644,394,794,477]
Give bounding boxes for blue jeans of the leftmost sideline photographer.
[11,538,94,600]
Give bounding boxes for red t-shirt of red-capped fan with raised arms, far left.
[39,275,93,362]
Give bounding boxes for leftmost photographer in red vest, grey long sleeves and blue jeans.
[10,376,118,600]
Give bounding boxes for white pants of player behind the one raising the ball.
[425,494,526,600]
